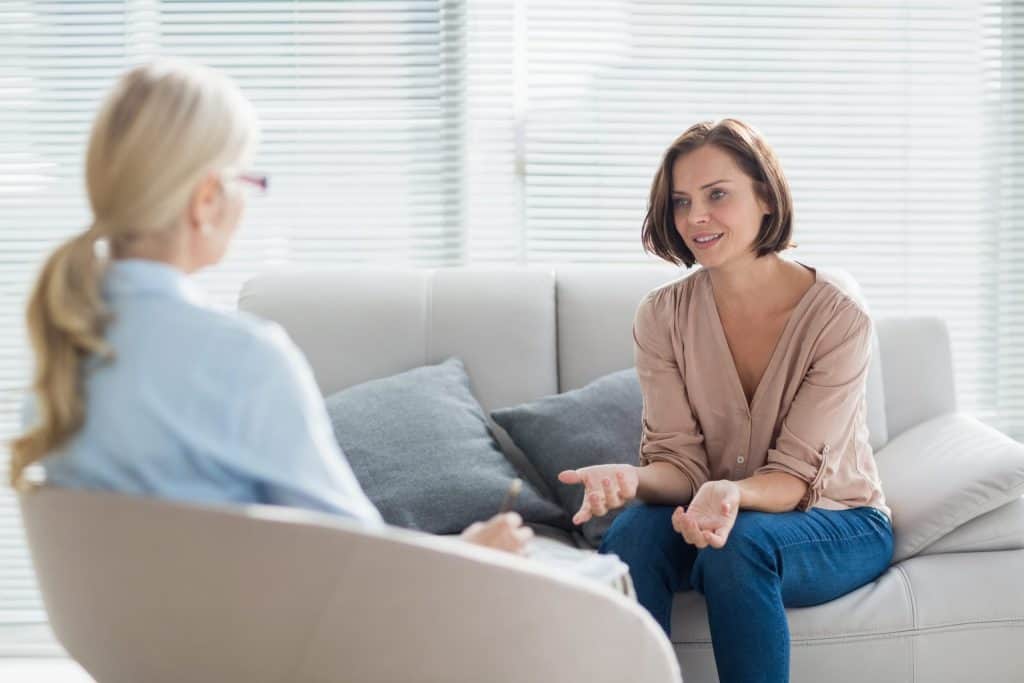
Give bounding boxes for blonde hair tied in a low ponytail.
[10,59,258,487]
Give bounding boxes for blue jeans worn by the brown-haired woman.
[599,505,893,683]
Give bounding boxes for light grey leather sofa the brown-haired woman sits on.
[240,265,1024,683]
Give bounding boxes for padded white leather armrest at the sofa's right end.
[876,414,1024,562]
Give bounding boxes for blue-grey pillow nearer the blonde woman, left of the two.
[327,358,564,533]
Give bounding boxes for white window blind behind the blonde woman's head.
[0,0,466,655]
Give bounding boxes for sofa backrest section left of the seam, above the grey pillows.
[239,268,558,411]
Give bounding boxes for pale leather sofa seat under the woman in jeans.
[671,550,1024,683]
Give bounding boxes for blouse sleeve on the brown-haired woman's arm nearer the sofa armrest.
[755,300,871,511]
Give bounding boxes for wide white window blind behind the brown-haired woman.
[503,0,998,432]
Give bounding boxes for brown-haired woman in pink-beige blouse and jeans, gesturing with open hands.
[560,119,893,683]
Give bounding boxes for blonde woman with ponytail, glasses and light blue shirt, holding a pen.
[10,60,531,552]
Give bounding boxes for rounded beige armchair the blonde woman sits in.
[19,488,679,683]
